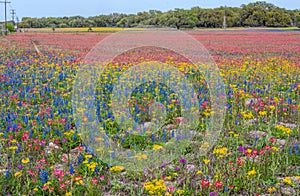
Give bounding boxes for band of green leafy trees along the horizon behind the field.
[19,1,300,29]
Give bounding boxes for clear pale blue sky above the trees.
[0,0,300,21]
